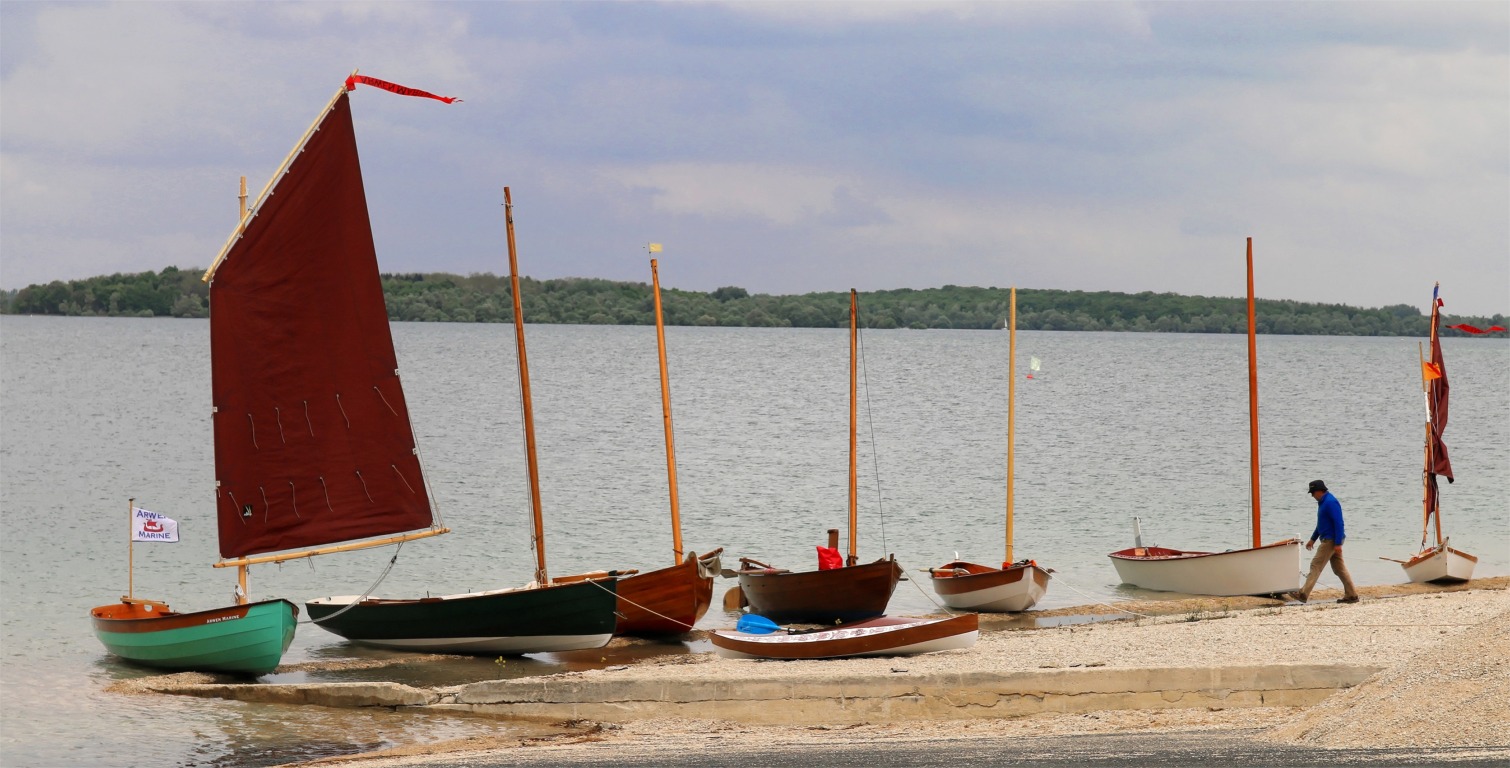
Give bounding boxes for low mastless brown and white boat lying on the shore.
[710,613,980,659]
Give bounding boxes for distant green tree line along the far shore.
[0,267,1507,336]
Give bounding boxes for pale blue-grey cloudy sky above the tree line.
[0,0,1510,315]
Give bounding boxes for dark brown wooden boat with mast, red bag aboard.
[737,290,901,623]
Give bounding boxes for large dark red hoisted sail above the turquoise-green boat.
[210,92,432,558]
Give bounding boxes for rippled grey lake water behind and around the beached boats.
[0,308,1510,766]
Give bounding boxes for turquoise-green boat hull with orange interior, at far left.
[91,599,299,674]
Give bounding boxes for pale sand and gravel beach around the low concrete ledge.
[265,576,1510,768]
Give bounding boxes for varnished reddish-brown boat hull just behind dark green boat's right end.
[613,548,723,635]
